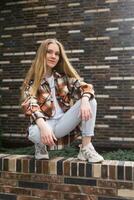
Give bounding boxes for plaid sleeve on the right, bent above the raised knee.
[68,78,94,99]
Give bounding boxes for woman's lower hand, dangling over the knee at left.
[36,118,57,146]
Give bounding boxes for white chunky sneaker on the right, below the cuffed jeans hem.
[77,143,104,163]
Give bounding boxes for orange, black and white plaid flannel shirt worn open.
[21,71,94,122]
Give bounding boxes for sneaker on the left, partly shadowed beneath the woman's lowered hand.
[35,143,49,160]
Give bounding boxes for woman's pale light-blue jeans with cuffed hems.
[28,99,97,143]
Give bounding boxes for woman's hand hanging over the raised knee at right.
[79,96,92,121]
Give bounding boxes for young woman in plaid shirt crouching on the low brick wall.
[22,39,104,162]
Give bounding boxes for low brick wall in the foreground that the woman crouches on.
[0,154,134,200]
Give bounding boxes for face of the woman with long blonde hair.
[46,43,60,68]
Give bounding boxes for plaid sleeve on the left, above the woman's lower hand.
[21,85,45,121]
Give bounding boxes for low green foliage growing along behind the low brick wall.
[0,145,134,161]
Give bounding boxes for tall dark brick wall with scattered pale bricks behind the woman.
[0,0,134,147]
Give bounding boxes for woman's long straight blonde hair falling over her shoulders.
[21,39,80,98]
